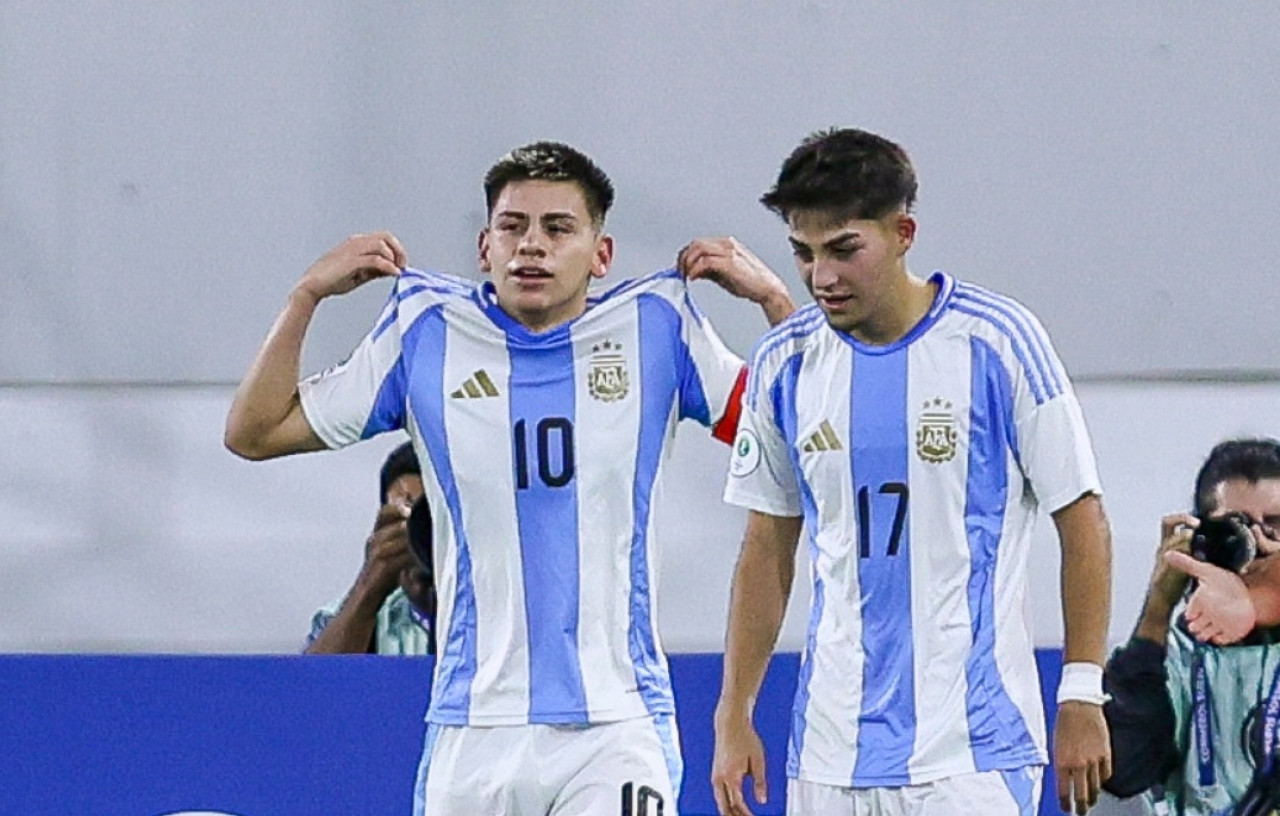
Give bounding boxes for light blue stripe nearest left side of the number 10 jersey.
[403,310,476,724]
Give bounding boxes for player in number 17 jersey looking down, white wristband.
[713,129,1111,816]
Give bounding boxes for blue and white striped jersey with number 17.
[726,272,1101,788]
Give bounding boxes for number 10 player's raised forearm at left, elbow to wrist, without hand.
[223,289,317,459]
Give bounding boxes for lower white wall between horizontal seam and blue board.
[0,382,1280,652]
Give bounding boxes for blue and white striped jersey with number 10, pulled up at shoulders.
[298,270,742,725]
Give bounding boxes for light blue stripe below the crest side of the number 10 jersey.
[628,297,687,714]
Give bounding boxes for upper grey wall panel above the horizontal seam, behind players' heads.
[0,0,1280,382]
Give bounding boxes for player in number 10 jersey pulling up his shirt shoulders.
[225,142,792,816]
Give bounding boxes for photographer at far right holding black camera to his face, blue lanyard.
[1103,439,1280,816]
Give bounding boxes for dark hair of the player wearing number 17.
[760,128,916,221]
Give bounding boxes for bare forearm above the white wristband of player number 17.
[1053,495,1111,666]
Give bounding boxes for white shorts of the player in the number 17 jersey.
[787,765,1044,816]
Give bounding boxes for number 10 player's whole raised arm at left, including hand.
[223,233,406,459]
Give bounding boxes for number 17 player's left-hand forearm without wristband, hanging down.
[717,532,795,716]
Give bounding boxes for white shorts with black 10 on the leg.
[413,715,684,816]
